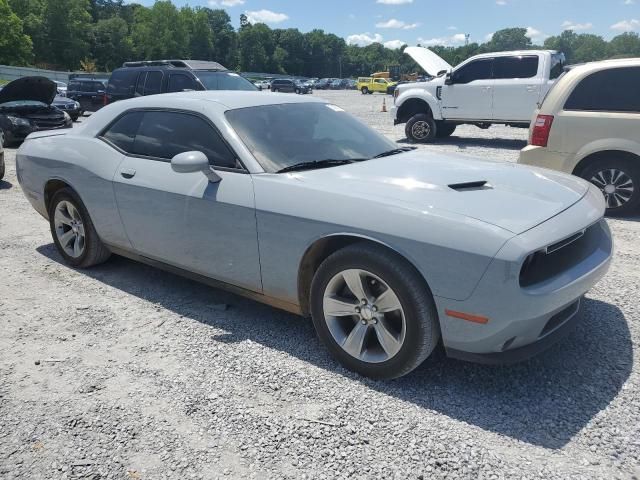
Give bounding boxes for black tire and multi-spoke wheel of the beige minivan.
[578,152,640,216]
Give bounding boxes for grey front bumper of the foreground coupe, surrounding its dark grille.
[435,187,613,363]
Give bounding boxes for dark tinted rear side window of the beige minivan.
[564,67,640,113]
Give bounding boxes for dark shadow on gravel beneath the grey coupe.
[37,244,633,449]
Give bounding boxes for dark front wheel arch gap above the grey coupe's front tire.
[298,233,432,316]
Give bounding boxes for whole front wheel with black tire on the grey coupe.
[310,243,440,379]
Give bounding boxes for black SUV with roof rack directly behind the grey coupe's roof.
[105,60,258,104]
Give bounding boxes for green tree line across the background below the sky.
[0,0,640,77]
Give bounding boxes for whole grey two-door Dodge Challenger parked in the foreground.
[16,91,613,378]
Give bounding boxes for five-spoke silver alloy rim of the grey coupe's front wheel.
[323,269,407,363]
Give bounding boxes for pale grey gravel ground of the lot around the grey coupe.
[0,92,640,479]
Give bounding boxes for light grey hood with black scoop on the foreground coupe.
[292,151,588,234]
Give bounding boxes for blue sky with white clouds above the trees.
[131,0,640,48]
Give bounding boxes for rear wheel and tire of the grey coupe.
[49,188,111,268]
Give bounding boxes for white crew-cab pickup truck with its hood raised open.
[391,47,565,143]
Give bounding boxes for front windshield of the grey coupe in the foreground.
[226,102,397,173]
